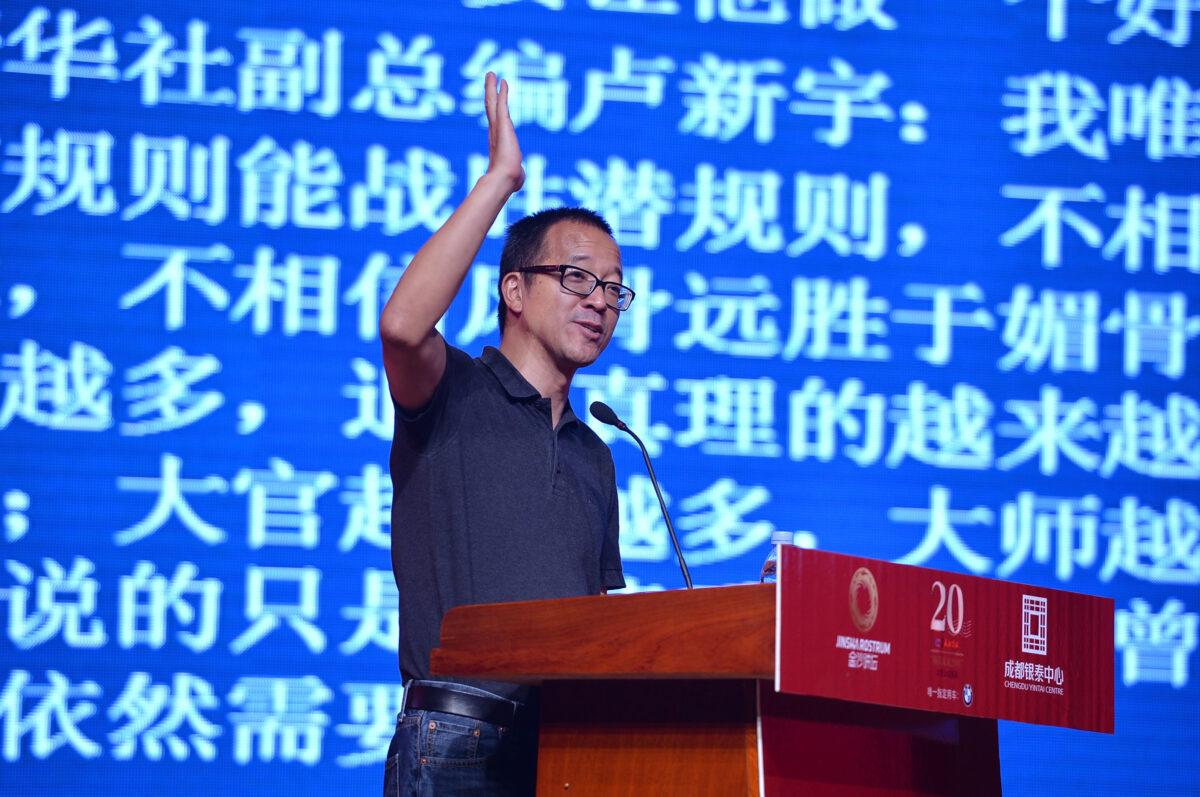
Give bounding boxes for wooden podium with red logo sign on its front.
[432,546,1114,797]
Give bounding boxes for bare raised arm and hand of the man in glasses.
[379,72,524,409]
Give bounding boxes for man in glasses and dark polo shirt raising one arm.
[379,73,632,796]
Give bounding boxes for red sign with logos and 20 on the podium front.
[775,545,1114,733]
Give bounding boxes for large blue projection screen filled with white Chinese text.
[0,0,1200,796]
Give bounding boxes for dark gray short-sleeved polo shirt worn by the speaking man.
[391,344,625,696]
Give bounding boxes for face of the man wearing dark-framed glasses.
[524,221,623,371]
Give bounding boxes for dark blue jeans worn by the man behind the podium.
[383,681,538,797]
